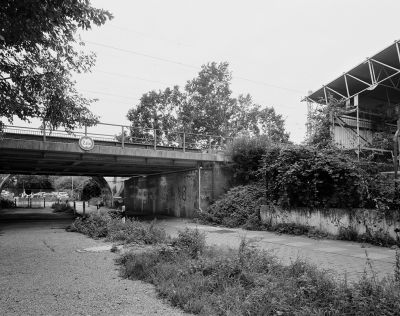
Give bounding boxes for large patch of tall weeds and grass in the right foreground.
[118,231,400,316]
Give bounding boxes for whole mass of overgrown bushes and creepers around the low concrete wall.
[202,137,400,246]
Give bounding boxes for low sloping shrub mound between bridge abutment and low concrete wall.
[197,184,265,228]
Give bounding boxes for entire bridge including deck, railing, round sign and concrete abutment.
[0,123,230,217]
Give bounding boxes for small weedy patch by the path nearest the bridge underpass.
[68,211,167,244]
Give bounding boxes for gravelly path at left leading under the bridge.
[0,210,189,315]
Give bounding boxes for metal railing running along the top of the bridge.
[4,123,232,151]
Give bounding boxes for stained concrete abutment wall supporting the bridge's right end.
[125,164,231,217]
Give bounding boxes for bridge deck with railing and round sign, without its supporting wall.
[0,123,227,177]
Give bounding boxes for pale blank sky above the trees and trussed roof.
[17,0,400,142]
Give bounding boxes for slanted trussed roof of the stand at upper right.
[306,41,400,110]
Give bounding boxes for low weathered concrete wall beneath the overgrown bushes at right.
[260,205,400,240]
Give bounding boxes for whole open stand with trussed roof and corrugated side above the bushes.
[303,41,400,166]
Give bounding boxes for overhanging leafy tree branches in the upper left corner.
[0,0,112,130]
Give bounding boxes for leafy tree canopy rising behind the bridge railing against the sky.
[127,62,289,142]
